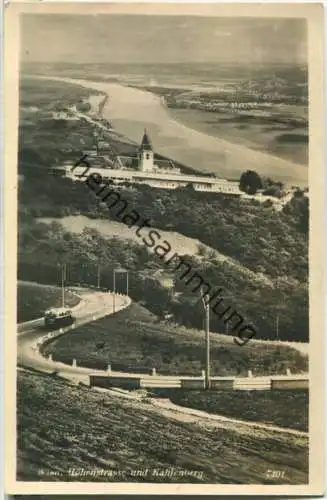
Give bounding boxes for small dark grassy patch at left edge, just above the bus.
[17,281,79,323]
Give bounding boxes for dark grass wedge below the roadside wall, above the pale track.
[153,389,309,431]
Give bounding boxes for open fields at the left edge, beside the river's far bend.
[19,77,102,172]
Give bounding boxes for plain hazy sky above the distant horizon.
[21,14,307,64]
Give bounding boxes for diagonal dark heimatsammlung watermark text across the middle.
[72,155,256,346]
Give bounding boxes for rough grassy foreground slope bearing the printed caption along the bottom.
[17,372,308,484]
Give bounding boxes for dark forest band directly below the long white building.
[20,172,308,282]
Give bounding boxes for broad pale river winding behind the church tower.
[37,77,308,186]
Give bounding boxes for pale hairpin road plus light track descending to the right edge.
[17,288,307,438]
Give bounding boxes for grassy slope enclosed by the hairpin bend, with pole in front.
[46,304,307,375]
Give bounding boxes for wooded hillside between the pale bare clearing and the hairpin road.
[18,211,308,341]
